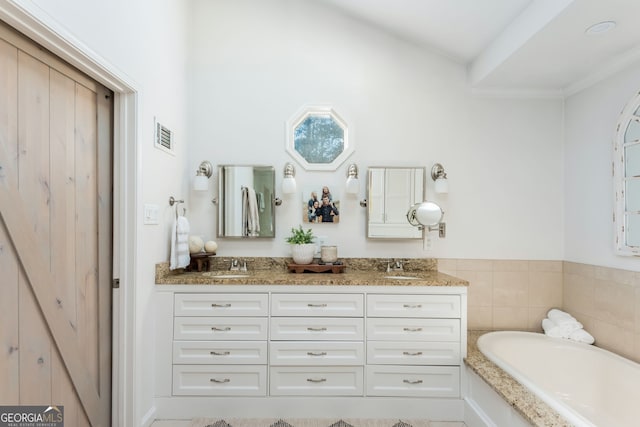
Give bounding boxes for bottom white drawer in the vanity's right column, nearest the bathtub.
[367,365,460,397]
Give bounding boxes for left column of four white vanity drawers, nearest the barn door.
[173,293,269,396]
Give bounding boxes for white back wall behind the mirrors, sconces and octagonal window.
[189,0,563,260]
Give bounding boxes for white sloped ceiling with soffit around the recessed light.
[318,0,640,96]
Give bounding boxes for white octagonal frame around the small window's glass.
[285,105,355,171]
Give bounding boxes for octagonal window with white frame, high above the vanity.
[287,107,353,170]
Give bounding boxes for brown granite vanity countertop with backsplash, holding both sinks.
[156,258,468,286]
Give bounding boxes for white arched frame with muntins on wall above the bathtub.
[613,95,640,256]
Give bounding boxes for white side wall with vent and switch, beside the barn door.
[18,0,188,425]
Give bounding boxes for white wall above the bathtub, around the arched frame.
[564,57,640,271]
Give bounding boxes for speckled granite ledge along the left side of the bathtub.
[465,331,572,427]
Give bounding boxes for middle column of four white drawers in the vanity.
[269,293,364,396]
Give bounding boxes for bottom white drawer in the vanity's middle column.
[269,366,363,396]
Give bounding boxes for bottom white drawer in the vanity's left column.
[173,365,267,396]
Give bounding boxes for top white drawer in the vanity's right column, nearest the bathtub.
[367,294,460,318]
